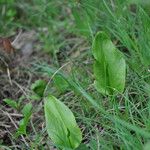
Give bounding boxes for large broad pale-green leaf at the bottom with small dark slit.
[44,95,82,149]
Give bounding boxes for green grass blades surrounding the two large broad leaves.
[0,0,150,150]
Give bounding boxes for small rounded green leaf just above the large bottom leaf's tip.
[31,80,46,97]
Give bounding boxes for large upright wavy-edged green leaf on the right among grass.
[92,32,126,94]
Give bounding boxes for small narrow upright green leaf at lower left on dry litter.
[16,103,32,136]
